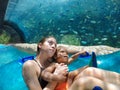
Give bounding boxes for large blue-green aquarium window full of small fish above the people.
[1,0,120,47]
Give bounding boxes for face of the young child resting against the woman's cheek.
[56,48,68,64]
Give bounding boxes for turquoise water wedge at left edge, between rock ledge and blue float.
[0,44,34,66]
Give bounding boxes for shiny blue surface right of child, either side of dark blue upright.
[69,51,120,73]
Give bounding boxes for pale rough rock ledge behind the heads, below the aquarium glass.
[9,43,120,55]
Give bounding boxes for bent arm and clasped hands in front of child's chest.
[41,63,67,82]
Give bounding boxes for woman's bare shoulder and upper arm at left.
[22,60,39,90]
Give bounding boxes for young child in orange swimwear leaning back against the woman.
[42,46,88,90]
